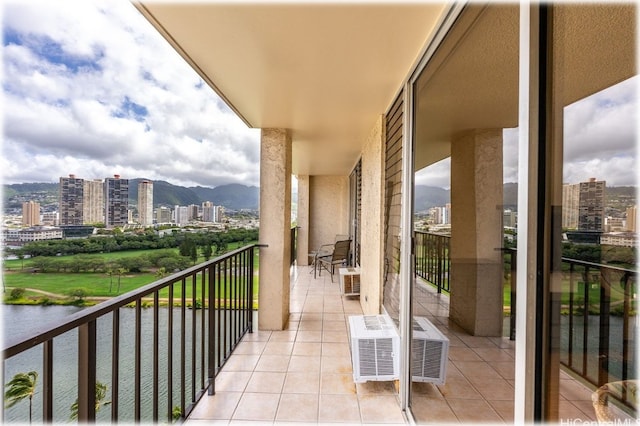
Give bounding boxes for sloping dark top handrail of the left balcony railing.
[2,244,263,360]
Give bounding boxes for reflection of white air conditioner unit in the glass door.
[411,317,449,385]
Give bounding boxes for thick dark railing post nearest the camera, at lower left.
[78,320,96,423]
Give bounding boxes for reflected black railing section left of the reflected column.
[414,231,451,293]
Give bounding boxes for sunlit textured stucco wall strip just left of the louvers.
[360,116,384,315]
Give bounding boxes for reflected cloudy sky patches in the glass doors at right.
[416,77,639,188]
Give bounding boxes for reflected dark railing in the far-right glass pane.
[556,258,638,403]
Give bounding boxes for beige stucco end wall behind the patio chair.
[309,176,349,250]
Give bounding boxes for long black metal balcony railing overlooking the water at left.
[2,245,259,423]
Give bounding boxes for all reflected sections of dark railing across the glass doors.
[415,231,639,405]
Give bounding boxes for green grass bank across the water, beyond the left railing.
[3,244,258,306]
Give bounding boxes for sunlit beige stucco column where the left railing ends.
[258,129,291,330]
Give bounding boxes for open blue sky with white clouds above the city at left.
[0,0,259,187]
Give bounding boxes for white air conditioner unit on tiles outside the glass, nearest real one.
[349,315,400,383]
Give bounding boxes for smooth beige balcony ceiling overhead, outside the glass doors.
[136,1,445,175]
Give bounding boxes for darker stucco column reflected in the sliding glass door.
[449,129,503,336]
